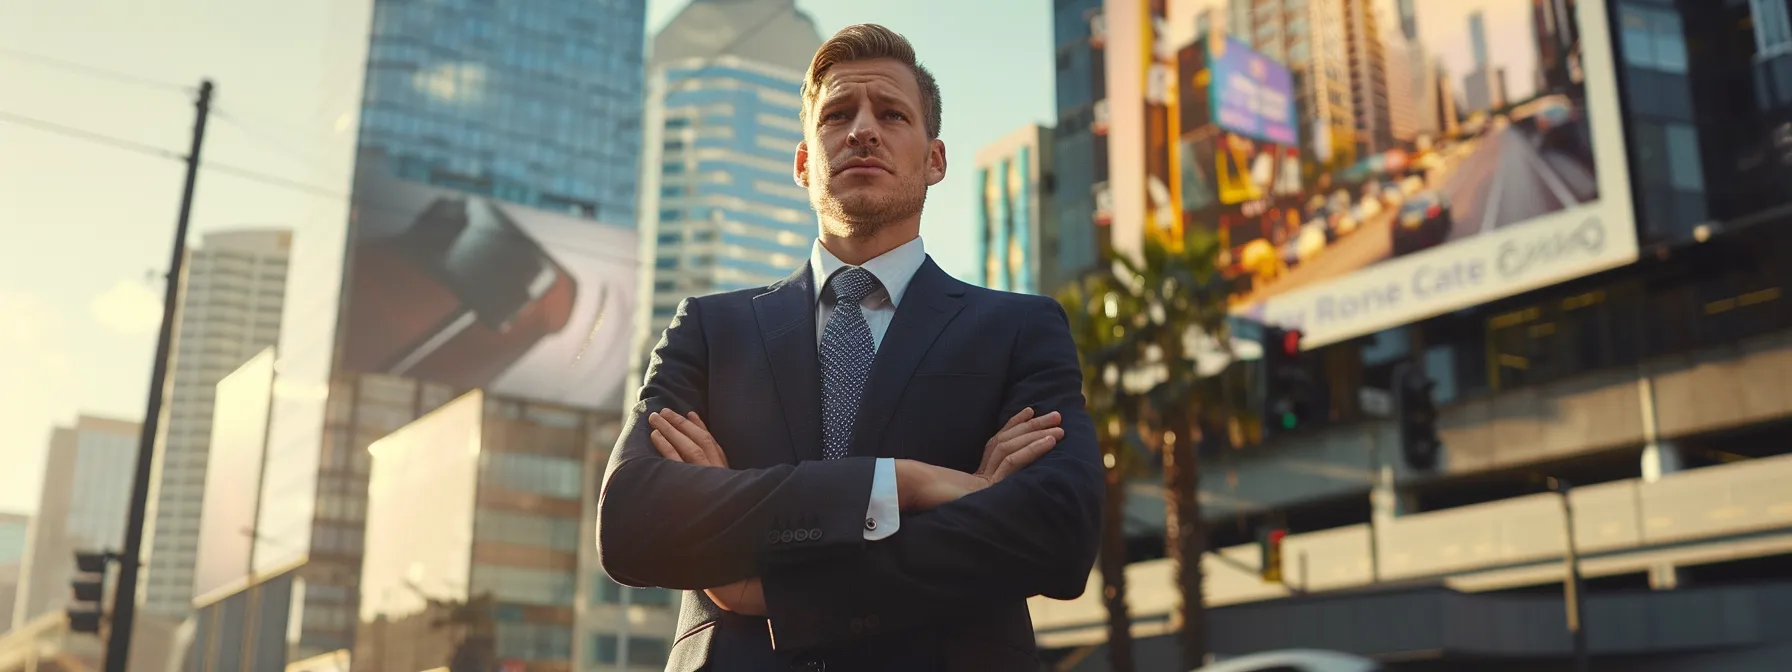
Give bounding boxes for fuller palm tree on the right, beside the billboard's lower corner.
[1109,228,1231,668]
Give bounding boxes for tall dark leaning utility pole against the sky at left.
[106,79,211,672]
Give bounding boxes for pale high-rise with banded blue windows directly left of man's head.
[629,0,821,385]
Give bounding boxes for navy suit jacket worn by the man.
[597,258,1102,672]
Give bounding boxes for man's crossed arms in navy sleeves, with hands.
[599,301,1100,649]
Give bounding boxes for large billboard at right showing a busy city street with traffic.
[1161,0,1636,346]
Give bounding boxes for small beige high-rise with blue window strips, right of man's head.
[975,124,1073,294]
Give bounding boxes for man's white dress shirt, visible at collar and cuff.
[808,237,926,541]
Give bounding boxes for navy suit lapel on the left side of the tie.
[753,263,821,462]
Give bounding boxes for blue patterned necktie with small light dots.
[821,265,880,461]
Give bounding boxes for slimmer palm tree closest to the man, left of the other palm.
[1057,272,1138,672]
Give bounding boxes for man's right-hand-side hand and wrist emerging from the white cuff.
[896,409,1064,511]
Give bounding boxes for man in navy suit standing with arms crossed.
[599,25,1102,672]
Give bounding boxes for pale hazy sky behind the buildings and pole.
[0,0,1055,513]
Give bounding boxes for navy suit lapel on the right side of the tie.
[851,256,964,457]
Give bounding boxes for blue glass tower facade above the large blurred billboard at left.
[360,0,647,226]
